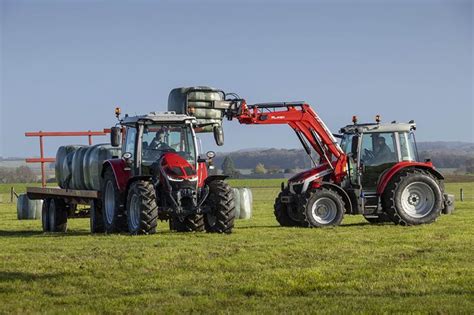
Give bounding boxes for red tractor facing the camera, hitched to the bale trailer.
[97,112,235,234]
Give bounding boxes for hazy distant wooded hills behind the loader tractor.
[215,141,474,169]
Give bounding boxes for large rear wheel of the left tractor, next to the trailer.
[101,168,126,233]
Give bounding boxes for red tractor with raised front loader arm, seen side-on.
[206,98,454,227]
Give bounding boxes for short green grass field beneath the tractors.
[0,180,474,313]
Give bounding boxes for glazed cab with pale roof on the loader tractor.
[340,118,419,211]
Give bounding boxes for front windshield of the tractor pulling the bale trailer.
[142,124,196,165]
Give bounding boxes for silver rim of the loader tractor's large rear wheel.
[401,182,435,218]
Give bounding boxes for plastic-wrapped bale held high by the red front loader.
[168,86,225,132]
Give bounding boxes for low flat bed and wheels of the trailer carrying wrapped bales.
[26,187,101,232]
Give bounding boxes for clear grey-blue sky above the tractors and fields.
[0,0,474,157]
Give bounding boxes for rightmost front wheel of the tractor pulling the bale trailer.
[204,180,235,234]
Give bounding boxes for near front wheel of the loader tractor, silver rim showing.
[299,188,344,228]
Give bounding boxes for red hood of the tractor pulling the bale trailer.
[160,152,197,181]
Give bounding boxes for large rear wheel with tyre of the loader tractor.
[382,170,443,225]
